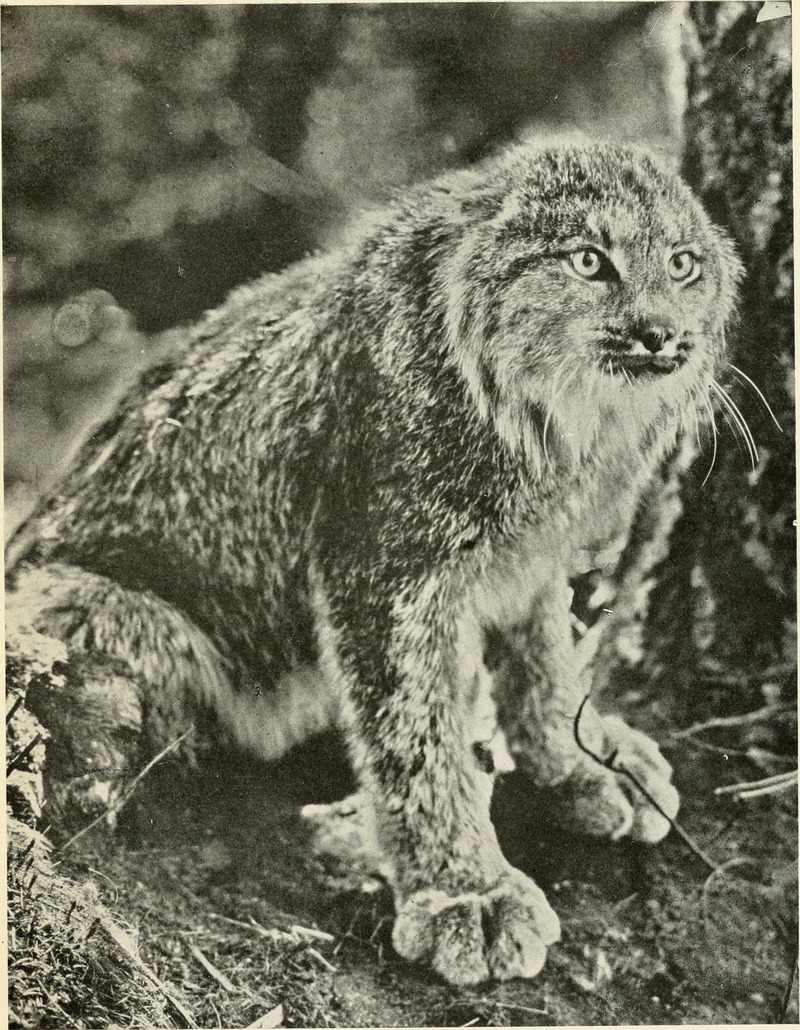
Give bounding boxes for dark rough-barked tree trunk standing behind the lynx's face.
[595,2,796,707]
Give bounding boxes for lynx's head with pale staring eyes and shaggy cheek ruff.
[447,145,741,470]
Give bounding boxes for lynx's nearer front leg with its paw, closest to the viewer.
[320,569,559,985]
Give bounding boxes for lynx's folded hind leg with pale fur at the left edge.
[7,563,335,795]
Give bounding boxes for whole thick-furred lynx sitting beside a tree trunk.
[9,145,740,984]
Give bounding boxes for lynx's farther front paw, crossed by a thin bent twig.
[565,717,680,844]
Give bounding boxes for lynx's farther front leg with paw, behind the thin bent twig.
[496,581,679,843]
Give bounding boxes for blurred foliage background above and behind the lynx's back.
[2,3,683,531]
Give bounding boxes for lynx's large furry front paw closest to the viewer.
[392,868,561,987]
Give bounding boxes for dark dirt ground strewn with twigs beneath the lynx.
[48,688,798,1028]
